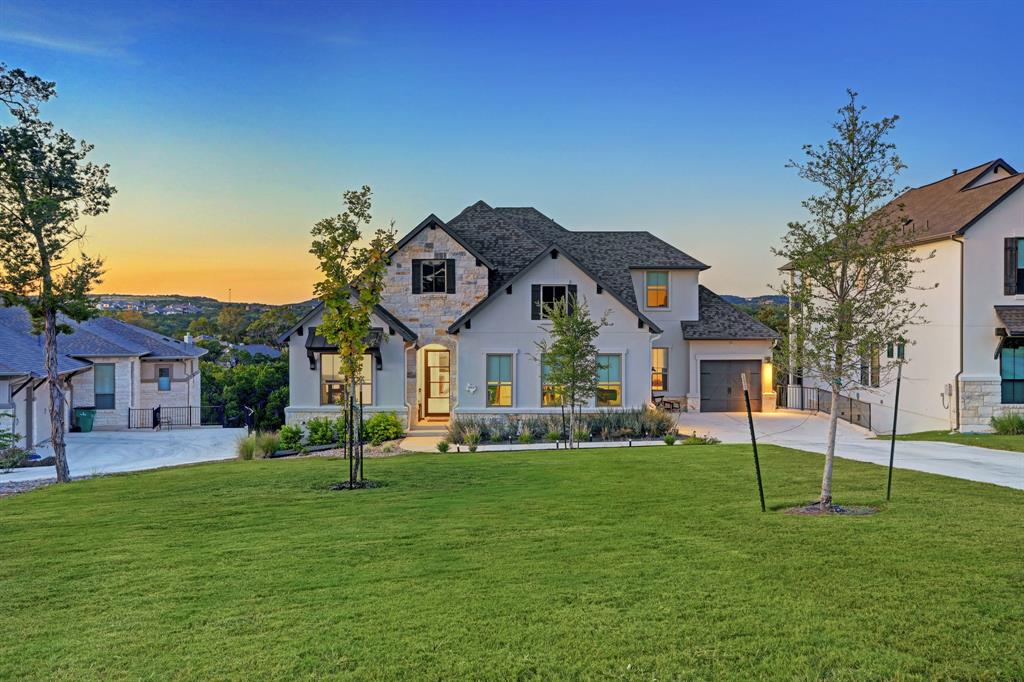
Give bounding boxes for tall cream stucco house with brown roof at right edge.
[791,159,1024,433]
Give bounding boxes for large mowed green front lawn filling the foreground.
[0,445,1024,680]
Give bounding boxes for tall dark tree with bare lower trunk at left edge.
[0,68,116,482]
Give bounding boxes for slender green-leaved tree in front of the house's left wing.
[309,185,395,485]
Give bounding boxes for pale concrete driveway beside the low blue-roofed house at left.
[0,427,240,482]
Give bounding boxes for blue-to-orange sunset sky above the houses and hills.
[0,0,1024,303]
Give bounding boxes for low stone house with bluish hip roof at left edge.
[0,308,206,446]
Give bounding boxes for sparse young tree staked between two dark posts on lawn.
[773,91,923,508]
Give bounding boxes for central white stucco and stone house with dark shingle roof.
[280,202,777,426]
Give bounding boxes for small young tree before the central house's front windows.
[536,299,608,449]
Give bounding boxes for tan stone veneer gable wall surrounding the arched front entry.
[381,227,487,417]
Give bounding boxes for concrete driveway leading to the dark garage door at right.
[678,411,1024,489]
